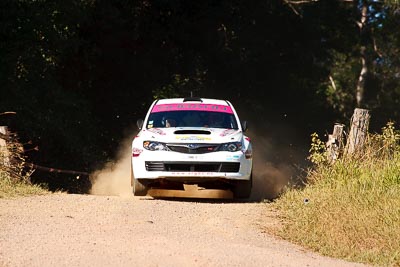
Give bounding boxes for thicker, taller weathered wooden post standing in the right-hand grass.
[346,108,371,155]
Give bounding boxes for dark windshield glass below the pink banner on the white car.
[146,110,238,129]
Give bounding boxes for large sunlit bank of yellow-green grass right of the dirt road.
[273,128,400,266]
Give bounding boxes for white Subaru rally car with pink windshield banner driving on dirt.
[131,97,253,198]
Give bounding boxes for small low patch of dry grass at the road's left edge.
[0,171,50,198]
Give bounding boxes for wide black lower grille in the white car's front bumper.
[145,161,240,172]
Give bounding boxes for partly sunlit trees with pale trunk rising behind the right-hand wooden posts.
[285,0,399,123]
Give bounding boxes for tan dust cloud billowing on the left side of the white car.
[90,139,133,197]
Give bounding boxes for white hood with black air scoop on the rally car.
[140,127,243,143]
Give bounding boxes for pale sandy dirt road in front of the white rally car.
[0,194,368,267]
